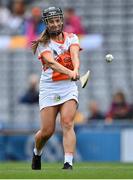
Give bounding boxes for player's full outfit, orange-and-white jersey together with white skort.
[37,32,79,110]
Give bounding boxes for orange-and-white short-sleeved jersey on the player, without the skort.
[37,32,79,82]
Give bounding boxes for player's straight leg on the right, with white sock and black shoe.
[60,100,77,169]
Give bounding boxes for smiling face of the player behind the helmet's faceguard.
[47,16,63,32]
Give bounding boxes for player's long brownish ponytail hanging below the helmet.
[31,29,50,54]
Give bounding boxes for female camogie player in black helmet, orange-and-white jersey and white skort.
[32,7,80,170]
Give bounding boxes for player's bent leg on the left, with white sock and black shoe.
[32,106,58,170]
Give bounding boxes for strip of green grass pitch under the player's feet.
[0,162,133,179]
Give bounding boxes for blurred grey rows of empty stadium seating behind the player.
[0,0,133,125]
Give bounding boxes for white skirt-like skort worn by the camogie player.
[39,80,78,110]
